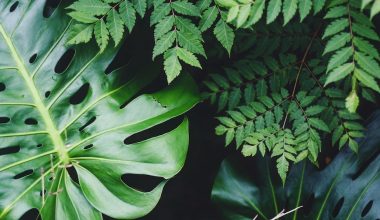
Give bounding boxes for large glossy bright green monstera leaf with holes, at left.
[0,0,198,220]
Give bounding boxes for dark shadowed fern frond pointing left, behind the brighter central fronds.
[204,54,297,111]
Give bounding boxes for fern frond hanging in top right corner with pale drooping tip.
[323,0,380,112]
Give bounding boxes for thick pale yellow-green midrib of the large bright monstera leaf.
[0,23,69,163]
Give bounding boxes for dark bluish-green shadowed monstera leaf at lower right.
[212,112,380,220]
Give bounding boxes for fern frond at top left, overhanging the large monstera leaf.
[67,0,147,49]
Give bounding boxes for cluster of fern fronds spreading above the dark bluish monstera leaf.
[205,27,364,181]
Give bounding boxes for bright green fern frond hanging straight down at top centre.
[150,0,207,83]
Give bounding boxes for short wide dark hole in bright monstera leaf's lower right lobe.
[121,174,164,192]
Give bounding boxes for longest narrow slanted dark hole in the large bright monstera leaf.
[124,117,183,145]
